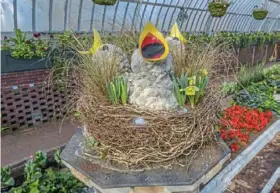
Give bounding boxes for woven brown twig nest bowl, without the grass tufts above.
[78,85,220,169]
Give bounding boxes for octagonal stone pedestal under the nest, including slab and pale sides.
[61,130,230,193]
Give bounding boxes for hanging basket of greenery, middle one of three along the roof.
[208,0,230,17]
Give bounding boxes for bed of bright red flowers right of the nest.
[219,105,273,152]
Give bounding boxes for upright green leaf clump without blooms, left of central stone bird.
[107,76,128,105]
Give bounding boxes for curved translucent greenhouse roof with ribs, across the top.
[1,0,280,33]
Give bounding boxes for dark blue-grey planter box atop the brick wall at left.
[1,51,51,73]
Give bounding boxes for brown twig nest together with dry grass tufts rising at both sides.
[58,37,235,170]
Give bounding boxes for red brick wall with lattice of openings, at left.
[1,70,69,130]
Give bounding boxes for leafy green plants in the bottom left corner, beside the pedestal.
[1,151,86,193]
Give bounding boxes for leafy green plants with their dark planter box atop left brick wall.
[1,29,50,73]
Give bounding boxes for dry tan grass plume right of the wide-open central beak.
[170,41,238,78]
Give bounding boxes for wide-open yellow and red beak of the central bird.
[139,22,169,61]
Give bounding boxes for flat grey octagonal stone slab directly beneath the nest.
[61,129,230,189]
